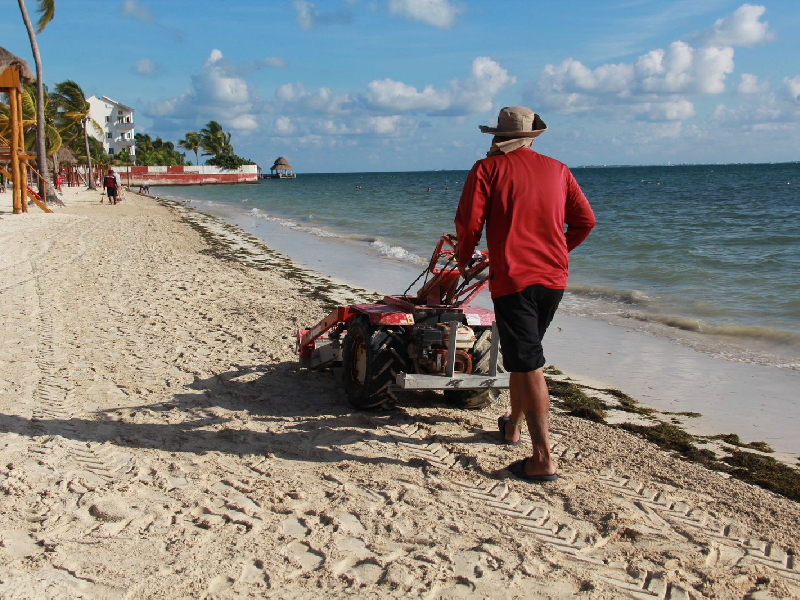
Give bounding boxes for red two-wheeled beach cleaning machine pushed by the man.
[297,233,509,408]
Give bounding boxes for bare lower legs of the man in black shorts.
[505,369,556,475]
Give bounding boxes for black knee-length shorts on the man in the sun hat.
[493,285,564,373]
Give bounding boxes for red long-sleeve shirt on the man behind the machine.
[455,148,595,298]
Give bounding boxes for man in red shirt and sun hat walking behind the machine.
[455,106,595,481]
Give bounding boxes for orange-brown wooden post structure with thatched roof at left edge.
[0,48,53,214]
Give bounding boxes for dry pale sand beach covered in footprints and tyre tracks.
[0,189,800,598]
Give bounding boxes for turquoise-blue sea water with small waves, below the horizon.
[153,163,800,370]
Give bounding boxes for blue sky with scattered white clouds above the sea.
[0,0,800,173]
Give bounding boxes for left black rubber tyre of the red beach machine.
[342,317,407,409]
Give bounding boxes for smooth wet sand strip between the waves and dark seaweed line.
[156,191,800,466]
